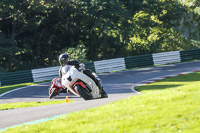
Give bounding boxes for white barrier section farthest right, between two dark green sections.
[152,51,181,65]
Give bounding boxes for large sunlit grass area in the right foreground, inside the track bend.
[1,73,200,133]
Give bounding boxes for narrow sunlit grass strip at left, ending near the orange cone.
[0,99,74,110]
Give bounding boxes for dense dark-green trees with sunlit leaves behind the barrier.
[0,0,200,72]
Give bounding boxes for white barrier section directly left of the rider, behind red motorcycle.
[32,66,60,82]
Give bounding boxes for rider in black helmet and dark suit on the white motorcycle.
[59,53,108,98]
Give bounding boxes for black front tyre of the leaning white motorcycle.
[74,85,92,100]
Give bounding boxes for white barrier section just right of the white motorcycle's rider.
[94,58,126,73]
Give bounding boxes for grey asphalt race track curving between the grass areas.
[0,61,200,129]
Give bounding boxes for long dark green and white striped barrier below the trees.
[0,49,200,86]
